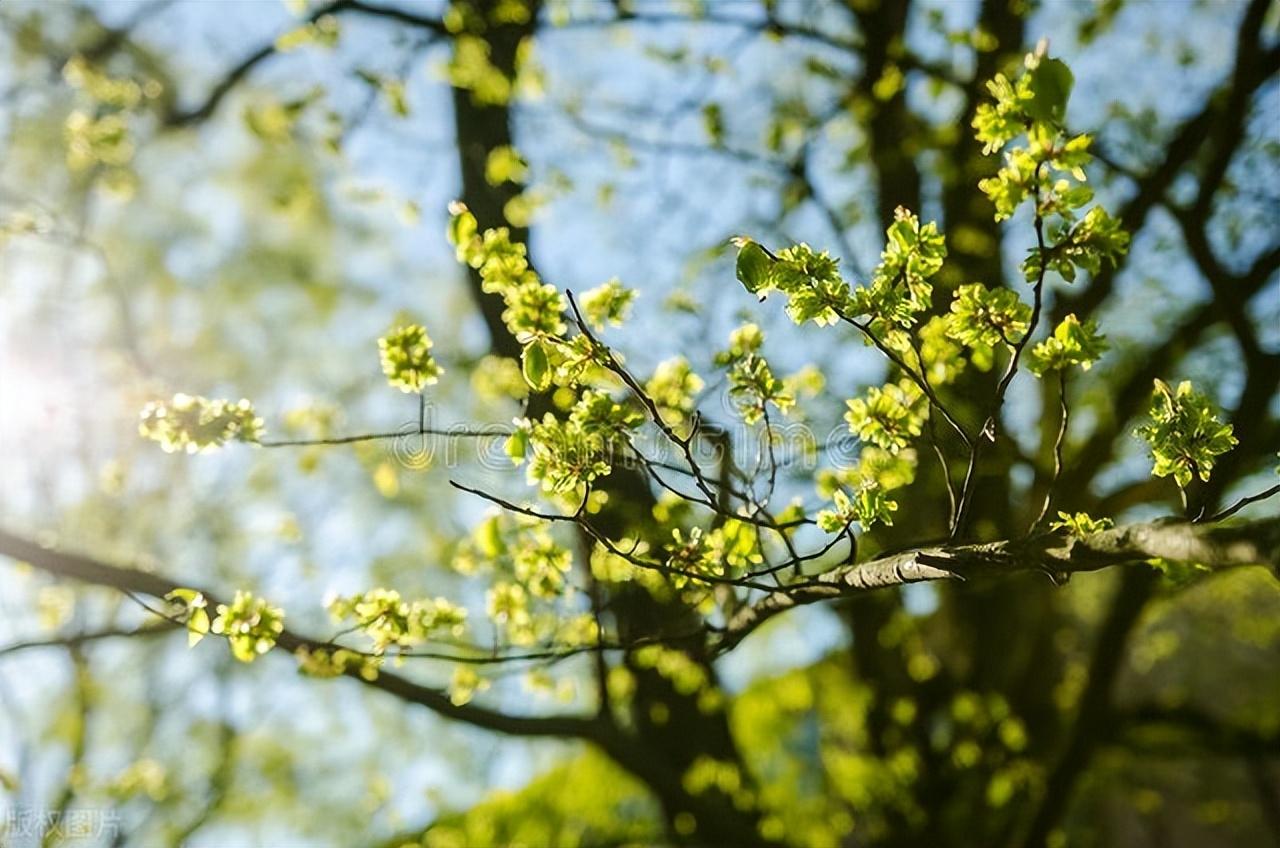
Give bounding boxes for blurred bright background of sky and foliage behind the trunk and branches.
[0,0,1280,845]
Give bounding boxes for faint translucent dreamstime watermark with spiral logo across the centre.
[387,405,861,475]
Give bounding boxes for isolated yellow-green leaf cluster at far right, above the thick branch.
[1137,379,1236,488]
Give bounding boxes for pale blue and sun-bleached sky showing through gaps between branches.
[0,3,1280,844]
